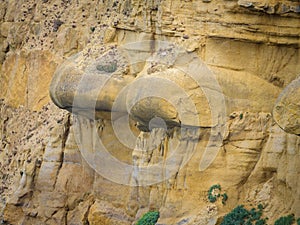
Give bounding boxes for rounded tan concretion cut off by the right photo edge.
[273,77,300,135]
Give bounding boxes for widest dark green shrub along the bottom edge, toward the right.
[221,205,267,225]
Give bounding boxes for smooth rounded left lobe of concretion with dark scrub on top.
[50,47,134,119]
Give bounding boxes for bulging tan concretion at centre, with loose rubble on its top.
[126,43,225,130]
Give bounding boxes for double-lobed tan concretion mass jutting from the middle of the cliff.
[50,40,226,128]
